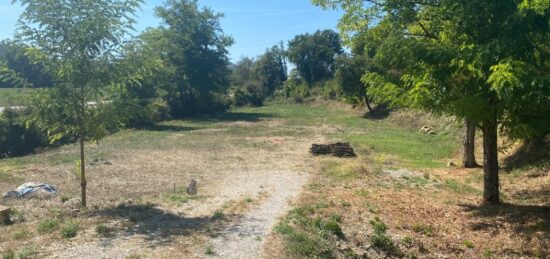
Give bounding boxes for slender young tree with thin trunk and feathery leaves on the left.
[14,0,142,207]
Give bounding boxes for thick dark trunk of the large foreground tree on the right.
[483,120,500,204]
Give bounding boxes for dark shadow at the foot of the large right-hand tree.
[460,203,550,237]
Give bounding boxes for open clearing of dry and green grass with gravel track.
[0,103,550,258]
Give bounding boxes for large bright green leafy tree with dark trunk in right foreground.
[314,0,550,203]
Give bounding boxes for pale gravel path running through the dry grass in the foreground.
[207,172,307,258]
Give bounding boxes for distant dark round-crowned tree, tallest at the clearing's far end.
[287,30,343,86]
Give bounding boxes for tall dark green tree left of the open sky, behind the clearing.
[156,0,233,117]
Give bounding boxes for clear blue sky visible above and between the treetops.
[0,0,341,61]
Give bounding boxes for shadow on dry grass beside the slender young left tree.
[88,204,236,246]
